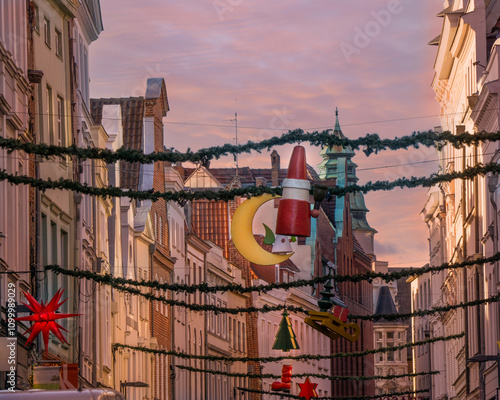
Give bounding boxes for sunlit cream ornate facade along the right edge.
[422,0,500,399]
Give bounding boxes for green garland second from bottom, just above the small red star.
[176,365,441,382]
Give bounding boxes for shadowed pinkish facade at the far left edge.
[0,1,34,388]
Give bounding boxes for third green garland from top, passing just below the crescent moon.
[44,252,500,293]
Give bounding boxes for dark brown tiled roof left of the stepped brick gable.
[90,97,144,190]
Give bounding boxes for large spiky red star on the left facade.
[15,289,81,352]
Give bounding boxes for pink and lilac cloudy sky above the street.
[90,0,442,267]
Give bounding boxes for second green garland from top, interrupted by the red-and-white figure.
[0,162,500,204]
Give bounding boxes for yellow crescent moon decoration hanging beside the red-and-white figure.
[231,193,293,265]
